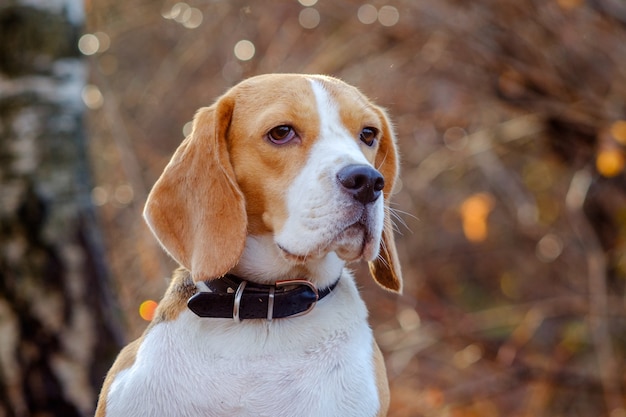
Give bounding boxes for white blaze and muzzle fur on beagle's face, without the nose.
[275,79,383,264]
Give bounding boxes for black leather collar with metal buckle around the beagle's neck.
[187,275,339,321]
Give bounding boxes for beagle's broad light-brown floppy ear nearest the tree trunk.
[144,97,247,281]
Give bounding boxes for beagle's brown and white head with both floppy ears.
[144,74,402,291]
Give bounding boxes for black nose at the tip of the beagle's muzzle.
[337,165,385,204]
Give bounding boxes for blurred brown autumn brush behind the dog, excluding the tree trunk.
[1,0,626,417]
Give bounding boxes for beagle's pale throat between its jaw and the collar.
[230,234,345,288]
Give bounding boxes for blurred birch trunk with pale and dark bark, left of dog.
[0,0,121,417]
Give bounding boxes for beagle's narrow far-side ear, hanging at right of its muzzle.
[369,109,402,293]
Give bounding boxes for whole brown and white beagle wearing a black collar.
[96,74,402,417]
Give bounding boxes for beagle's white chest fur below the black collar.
[107,275,379,417]
